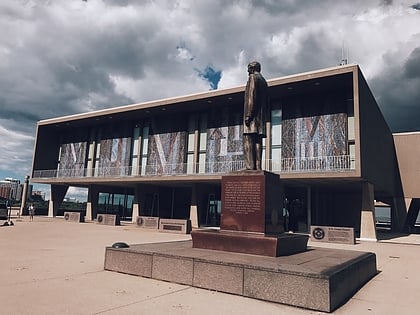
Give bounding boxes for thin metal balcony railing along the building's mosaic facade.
[33,155,355,178]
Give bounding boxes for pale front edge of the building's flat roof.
[38,64,359,125]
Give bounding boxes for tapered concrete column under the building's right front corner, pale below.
[360,182,378,242]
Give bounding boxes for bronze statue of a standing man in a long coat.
[243,61,268,170]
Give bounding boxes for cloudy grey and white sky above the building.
[0,0,420,200]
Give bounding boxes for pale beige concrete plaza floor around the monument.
[0,217,420,315]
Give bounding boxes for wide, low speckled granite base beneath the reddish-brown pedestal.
[105,241,377,312]
